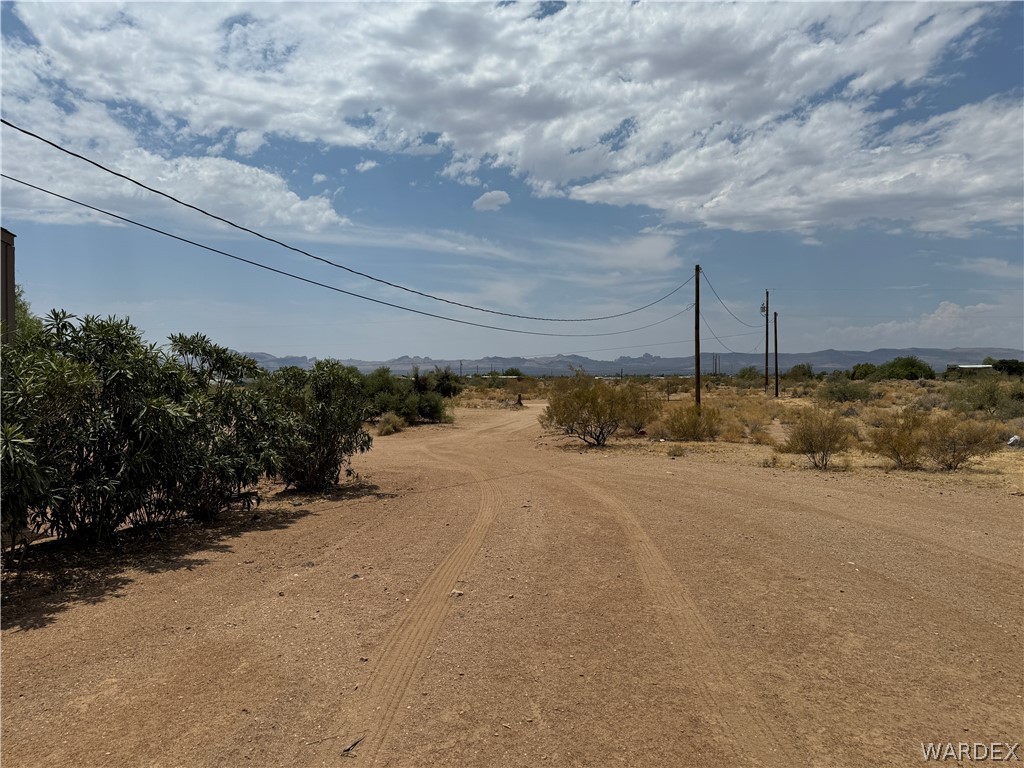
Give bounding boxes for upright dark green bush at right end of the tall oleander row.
[266,360,373,489]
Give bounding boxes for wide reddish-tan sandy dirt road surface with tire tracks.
[0,403,1024,768]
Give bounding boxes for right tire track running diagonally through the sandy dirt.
[551,469,798,768]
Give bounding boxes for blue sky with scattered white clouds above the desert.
[0,2,1024,359]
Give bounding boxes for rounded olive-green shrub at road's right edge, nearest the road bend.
[540,369,624,445]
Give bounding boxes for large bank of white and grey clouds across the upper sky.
[3,3,1024,238]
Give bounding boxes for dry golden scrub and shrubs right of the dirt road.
[528,356,1024,471]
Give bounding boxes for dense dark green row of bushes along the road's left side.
[0,294,461,547]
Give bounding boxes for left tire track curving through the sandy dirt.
[311,447,502,765]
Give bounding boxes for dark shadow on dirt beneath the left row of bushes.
[0,482,389,631]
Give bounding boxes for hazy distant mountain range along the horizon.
[246,347,1024,376]
